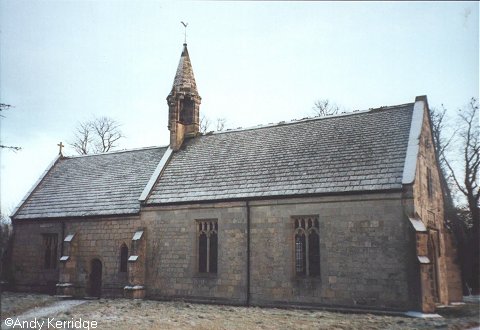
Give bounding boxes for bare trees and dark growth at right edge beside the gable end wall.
[431,98,480,293]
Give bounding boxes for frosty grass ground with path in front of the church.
[1,292,480,330]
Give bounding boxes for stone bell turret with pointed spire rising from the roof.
[167,39,202,150]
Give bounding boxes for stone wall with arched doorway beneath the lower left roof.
[13,217,144,297]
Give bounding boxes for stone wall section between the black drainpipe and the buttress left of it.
[142,203,247,304]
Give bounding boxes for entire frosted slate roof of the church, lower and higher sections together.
[13,102,423,219]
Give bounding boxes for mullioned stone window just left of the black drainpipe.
[197,220,218,274]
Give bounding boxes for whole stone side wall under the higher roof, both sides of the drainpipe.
[142,192,415,310]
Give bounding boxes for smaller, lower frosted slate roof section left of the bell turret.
[14,147,167,219]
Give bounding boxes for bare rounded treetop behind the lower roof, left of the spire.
[69,117,124,155]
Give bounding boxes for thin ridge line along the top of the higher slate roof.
[202,102,415,136]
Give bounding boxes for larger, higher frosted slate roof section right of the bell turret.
[146,103,414,205]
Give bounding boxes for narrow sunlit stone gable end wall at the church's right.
[405,101,461,312]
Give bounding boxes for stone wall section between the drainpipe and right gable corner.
[251,194,411,309]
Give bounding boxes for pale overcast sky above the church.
[0,0,479,213]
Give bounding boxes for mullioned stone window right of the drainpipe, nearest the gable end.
[294,216,320,277]
